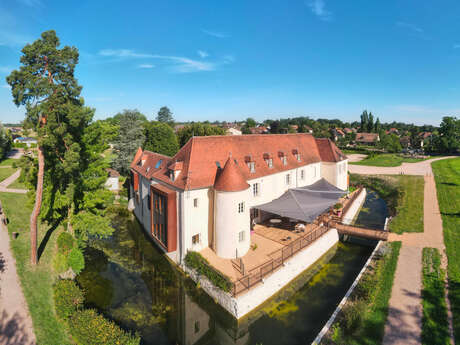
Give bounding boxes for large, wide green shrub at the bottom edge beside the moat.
[68,309,140,345]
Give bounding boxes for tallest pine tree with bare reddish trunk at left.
[7,30,87,265]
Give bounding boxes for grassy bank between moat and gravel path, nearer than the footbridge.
[322,242,401,345]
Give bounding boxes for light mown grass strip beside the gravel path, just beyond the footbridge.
[390,175,425,234]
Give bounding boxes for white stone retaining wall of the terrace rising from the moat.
[184,229,339,319]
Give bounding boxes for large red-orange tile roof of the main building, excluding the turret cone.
[131,133,345,190]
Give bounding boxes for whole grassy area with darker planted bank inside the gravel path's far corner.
[350,174,424,234]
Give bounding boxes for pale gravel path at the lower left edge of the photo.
[0,214,36,345]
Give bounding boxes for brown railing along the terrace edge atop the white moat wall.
[231,226,329,296]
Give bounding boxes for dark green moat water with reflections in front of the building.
[78,217,372,345]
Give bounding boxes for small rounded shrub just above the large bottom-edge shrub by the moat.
[53,279,84,320]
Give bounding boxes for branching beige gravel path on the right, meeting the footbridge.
[349,157,453,345]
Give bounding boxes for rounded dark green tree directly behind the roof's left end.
[143,121,179,156]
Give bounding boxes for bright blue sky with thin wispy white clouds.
[0,0,460,124]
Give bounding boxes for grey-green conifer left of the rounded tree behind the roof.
[112,110,145,175]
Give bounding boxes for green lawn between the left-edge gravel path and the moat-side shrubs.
[0,193,70,345]
